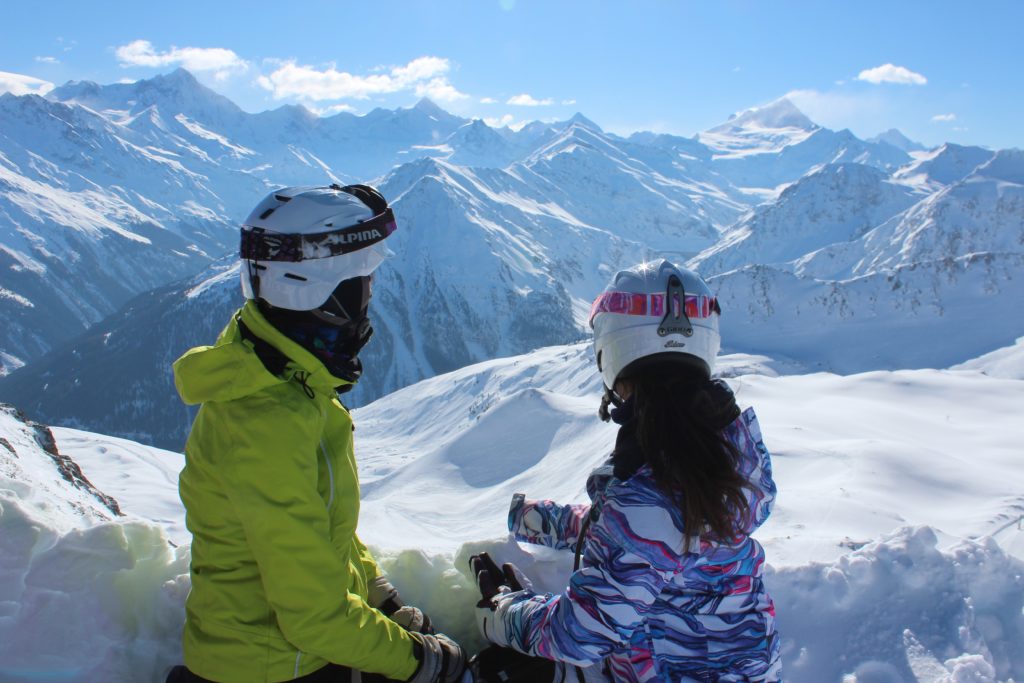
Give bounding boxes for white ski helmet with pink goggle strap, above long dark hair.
[590,260,721,388]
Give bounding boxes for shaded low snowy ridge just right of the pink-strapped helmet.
[710,254,1024,373]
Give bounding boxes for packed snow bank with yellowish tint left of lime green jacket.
[0,497,188,683]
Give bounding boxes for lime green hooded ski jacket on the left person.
[174,301,417,683]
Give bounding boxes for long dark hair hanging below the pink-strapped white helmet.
[629,364,751,546]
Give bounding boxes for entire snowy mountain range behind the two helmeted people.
[0,71,1024,449]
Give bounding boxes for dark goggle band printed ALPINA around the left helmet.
[240,208,398,263]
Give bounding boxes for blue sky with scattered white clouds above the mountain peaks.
[6,0,1024,147]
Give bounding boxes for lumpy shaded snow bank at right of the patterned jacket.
[765,526,1024,683]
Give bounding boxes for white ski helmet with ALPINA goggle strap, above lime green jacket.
[241,184,396,310]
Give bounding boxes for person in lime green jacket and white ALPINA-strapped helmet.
[168,184,470,683]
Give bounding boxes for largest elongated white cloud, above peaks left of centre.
[256,56,468,101]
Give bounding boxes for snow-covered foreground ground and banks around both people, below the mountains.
[0,343,1024,683]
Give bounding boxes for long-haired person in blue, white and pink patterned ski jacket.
[471,261,782,683]
